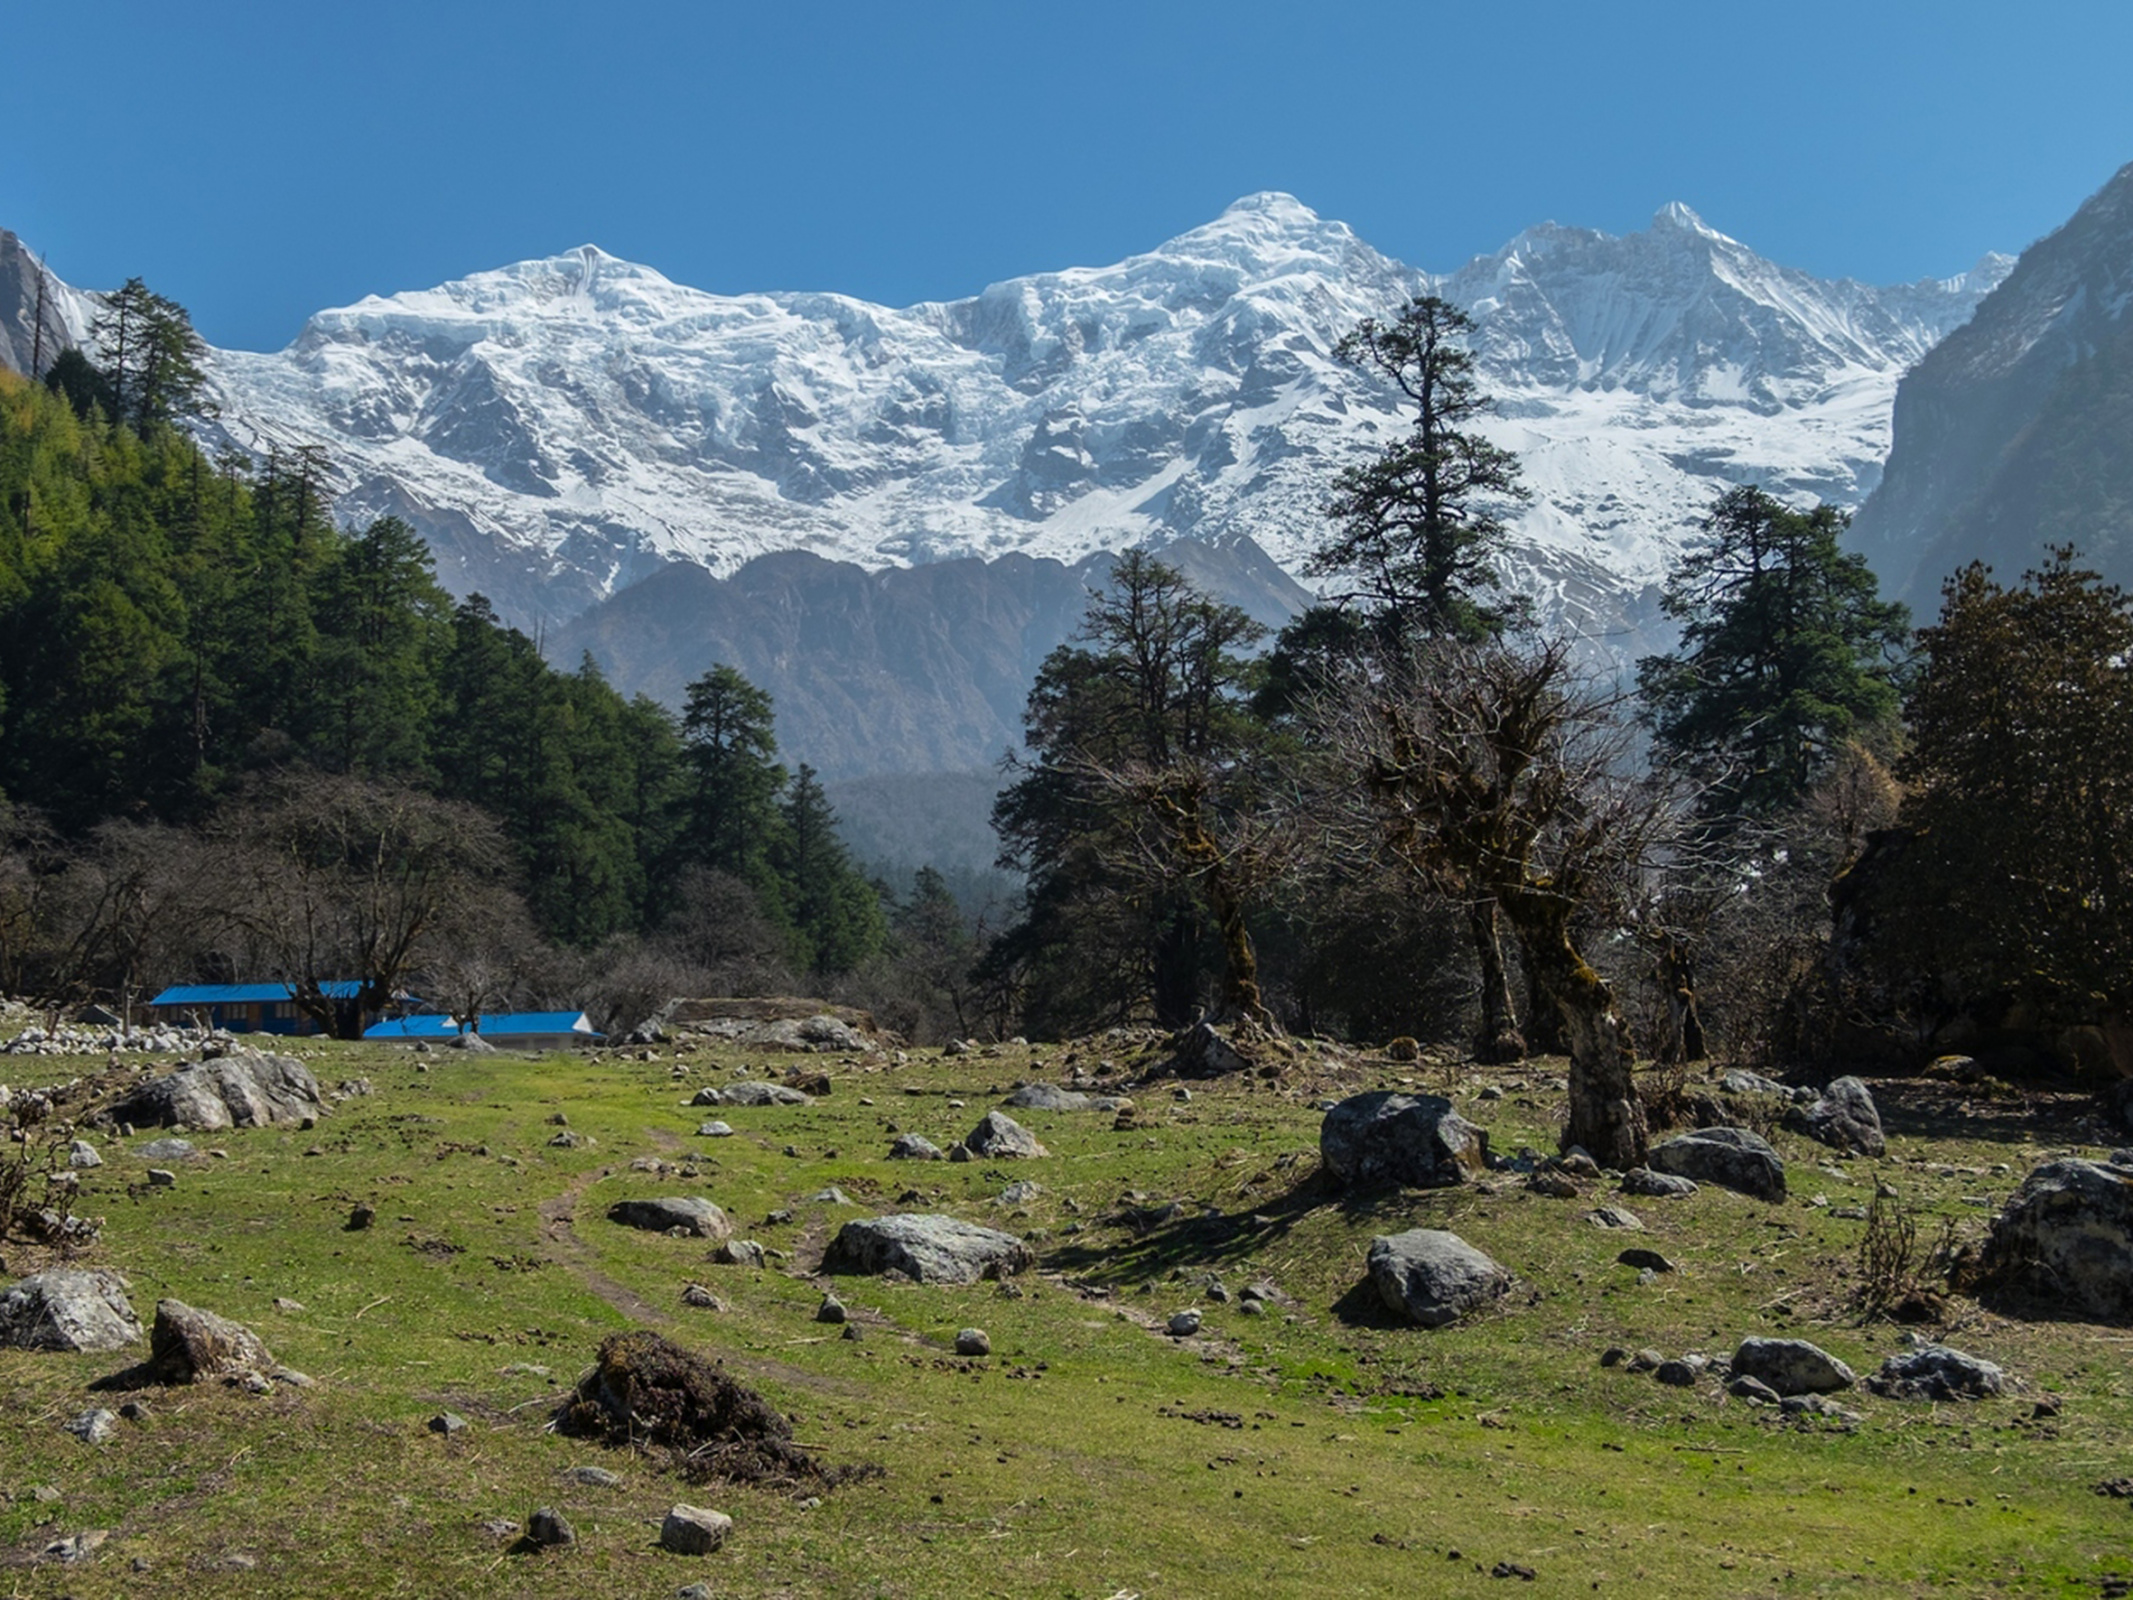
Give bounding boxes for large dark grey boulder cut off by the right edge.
[1984,1156,2133,1316]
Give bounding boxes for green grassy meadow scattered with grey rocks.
[0,1047,2133,1600]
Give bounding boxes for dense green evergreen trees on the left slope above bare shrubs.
[0,326,917,1032]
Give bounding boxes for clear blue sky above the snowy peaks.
[0,0,2133,350]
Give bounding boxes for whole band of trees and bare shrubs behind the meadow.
[0,284,2133,1165]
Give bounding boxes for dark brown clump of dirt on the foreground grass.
[557,1329,881,1489]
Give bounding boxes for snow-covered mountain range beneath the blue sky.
[183,194,2011,631]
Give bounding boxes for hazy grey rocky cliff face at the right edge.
[1854,166,2133,619]
